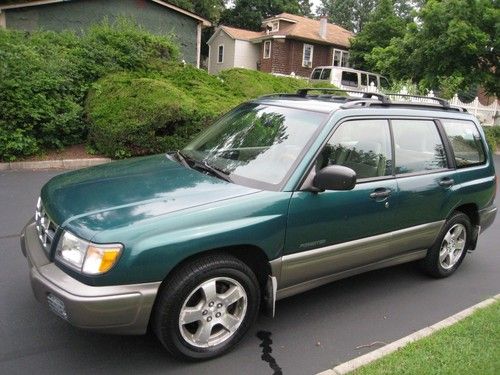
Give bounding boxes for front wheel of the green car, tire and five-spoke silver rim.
[152,254,260,361]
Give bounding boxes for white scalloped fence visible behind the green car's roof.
[340,83,500,126]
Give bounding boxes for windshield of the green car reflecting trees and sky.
[183,103,328,190]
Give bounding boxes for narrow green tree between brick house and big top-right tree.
[350,0,407,71]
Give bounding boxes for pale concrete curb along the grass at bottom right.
[316,294,500,375]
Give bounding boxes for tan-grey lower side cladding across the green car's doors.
[270,220,445,299]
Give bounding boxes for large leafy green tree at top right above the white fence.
[368,0,500,96]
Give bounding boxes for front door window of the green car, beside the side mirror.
[316,120,392,179]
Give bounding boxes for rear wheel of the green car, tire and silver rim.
[421,211,472,278]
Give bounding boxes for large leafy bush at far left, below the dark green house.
[0,19,179,160]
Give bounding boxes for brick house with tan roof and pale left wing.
[207,13,354,77]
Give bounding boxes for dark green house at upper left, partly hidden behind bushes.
[0,0,211,67]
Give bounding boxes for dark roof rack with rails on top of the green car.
[297,87,467,112]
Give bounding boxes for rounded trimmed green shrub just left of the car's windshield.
[89,73,199,158]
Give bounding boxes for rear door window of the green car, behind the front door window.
[392,120,448,174]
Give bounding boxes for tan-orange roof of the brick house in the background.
[260,13,354,47]
